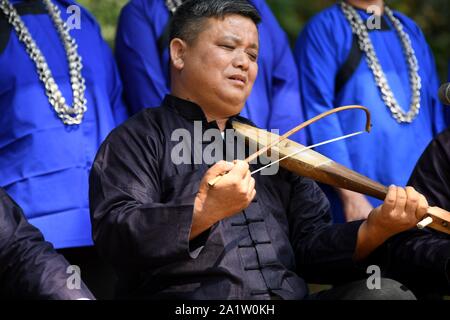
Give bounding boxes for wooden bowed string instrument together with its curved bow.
[215,106,450,234]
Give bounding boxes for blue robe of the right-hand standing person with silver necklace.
[294,4,444,220]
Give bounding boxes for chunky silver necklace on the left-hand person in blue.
[0,0,87,125]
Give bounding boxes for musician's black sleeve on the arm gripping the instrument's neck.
[289,177,365,283]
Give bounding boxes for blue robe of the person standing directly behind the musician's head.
[116,0,305,143]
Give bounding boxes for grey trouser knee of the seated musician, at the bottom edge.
[307,278,416,300]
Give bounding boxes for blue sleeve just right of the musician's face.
[259,2,306,144]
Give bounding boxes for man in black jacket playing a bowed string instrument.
[90,0,446,299]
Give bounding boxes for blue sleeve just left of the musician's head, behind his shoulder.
[115,1,169,114]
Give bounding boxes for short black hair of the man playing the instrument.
[169,0,261,43]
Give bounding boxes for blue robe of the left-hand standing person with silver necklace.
[0,0,126,248]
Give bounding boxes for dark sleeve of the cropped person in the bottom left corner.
[0,189,94,300]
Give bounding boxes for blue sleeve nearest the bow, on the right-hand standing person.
[294,19,352,169]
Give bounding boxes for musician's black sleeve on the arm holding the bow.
[89,122,204,272]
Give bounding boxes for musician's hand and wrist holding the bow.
[189,160,256,240]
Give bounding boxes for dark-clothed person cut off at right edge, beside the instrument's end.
[378,128,450,299]
